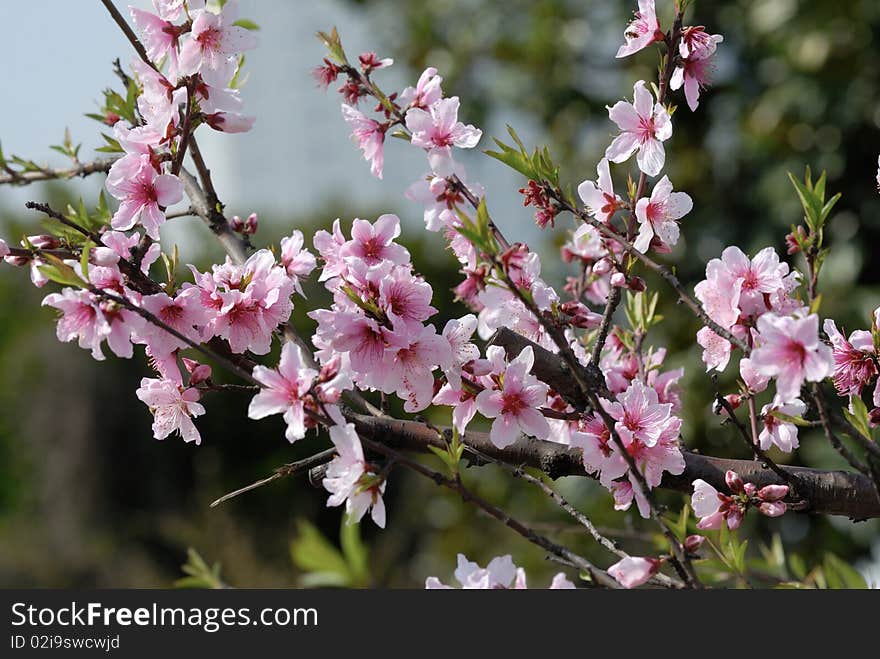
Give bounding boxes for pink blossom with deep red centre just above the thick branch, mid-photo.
[477,346,550,448]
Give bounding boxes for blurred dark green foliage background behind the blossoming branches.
[0,0,880,586]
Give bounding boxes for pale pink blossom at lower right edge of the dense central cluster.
[381,325,452,412]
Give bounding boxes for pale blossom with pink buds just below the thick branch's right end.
[691,471,789,531]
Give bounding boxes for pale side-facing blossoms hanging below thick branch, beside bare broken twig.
[322,423,385,529]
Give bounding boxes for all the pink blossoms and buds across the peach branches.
[6,0,868,589]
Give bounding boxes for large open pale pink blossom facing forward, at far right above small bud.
[751,313,834,403]
